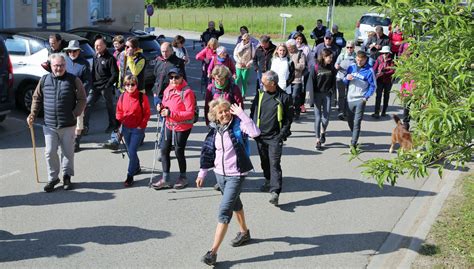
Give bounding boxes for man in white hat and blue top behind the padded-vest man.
[64,40,92,152]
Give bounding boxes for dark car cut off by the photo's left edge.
[0,37,15,122]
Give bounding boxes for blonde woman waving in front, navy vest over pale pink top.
[196,98,260,265]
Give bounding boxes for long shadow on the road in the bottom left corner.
[0,226,171,262]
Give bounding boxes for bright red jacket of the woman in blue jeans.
[115,91,151,129]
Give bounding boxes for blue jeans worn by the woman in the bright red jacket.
[122,126,145,176]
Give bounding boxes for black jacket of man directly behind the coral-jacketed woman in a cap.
[153,53,187,105]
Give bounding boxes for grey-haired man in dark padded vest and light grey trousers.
[26,53,86,192]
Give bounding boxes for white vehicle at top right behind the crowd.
[355,13,392,45]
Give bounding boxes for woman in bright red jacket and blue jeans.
[115,75,150,187]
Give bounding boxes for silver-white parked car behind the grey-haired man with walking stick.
[0,28,94,111]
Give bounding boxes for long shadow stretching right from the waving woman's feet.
[215,232,422,268]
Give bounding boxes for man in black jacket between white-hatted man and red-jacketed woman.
[84,37,119,134]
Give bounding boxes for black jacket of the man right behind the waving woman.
[250,86,294,141]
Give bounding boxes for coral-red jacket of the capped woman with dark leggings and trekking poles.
[162,80,196,132]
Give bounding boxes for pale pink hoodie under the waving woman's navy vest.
[198,111,260,178]
